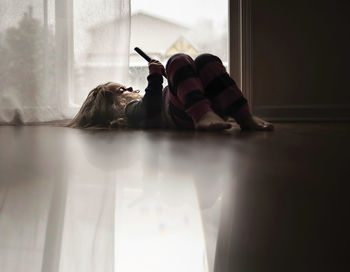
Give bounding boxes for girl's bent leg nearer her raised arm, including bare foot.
[166,54,230,129]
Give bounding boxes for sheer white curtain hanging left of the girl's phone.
[0,0,130,123]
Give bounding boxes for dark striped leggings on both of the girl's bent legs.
[166,54,251,129]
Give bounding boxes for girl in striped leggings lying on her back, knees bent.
[70,54,273,130]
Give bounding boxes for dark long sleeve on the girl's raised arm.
[125,73,163,128]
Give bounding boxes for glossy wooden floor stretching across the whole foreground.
[0,123,350,272]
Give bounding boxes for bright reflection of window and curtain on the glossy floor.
[0,127,232,272]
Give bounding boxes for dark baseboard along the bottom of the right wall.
[253,105,350,122]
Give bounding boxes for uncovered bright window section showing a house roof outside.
[129,0,228,91]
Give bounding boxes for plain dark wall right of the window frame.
[251,0,350,118]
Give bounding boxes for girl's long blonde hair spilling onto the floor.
[68,82,142,128]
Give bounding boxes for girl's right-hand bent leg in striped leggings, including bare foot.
[195,54,273,130]
